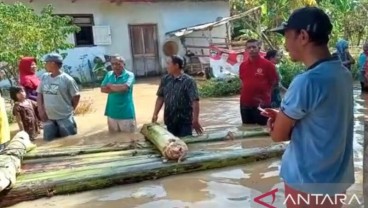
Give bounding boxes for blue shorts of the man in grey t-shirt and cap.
[43,116,77,141]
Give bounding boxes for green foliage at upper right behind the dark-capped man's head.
[231,0,368,48]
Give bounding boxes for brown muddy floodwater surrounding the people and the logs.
[8,83,365,208]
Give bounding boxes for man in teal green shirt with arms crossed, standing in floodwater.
[101,55,136,133]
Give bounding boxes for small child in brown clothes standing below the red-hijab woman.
[10,87,40,141]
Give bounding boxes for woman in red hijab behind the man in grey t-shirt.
[19,57,40,101]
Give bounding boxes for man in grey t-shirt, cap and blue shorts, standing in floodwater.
[37,53,80,140]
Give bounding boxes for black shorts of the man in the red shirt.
[240,106,268,126]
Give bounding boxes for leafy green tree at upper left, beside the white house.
[0,3,79,83]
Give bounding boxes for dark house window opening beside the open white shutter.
[68,14,94,46]
